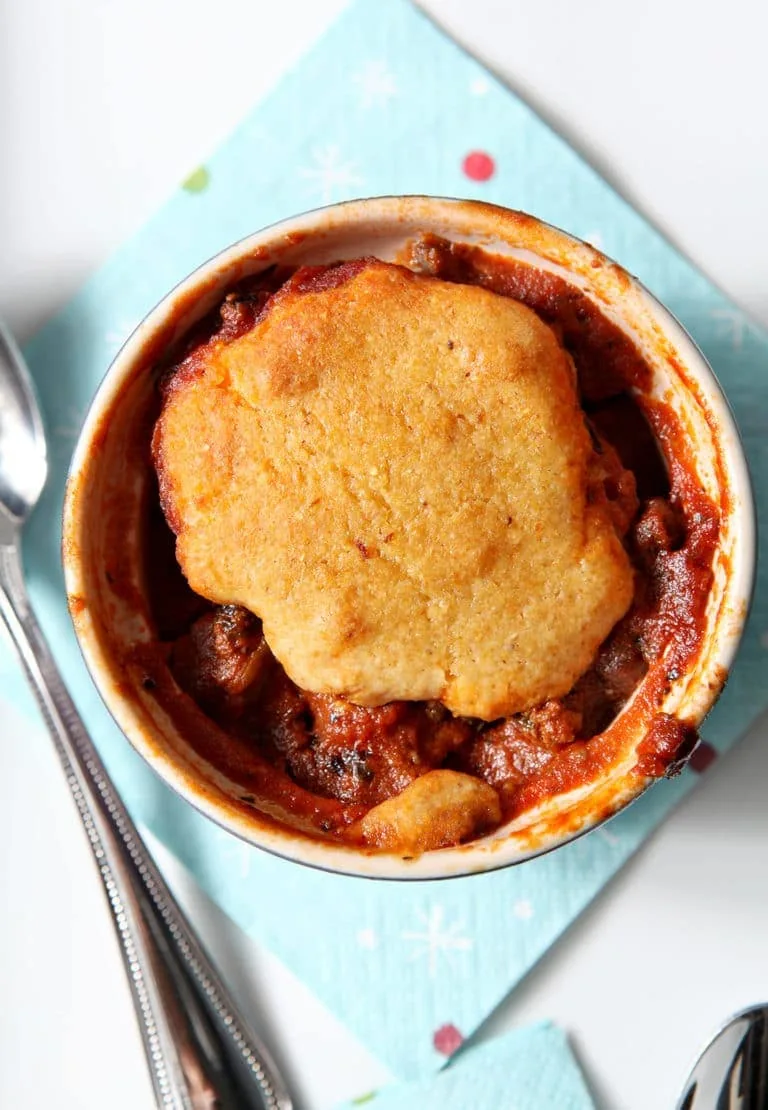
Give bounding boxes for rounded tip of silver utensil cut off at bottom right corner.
[676,1005,768,1110]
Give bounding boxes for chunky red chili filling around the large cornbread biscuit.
[142,236,719,842]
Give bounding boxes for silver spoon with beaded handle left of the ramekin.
[0,324,292,1110]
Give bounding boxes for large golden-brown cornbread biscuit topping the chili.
[153,261,633,719]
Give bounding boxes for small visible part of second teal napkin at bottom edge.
[337,1025,595,1110]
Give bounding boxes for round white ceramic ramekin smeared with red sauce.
[63,196,755,879]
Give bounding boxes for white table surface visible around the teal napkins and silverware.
[0,0,768,1110]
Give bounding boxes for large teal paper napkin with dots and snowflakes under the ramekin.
[0,0,768,1077]
